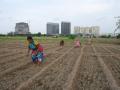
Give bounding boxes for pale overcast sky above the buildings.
[0,0,120,34]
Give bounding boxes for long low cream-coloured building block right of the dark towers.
[74,26,100,37]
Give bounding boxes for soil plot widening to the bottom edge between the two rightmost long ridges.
[72,55,111,90]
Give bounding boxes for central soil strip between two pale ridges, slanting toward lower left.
[18,49,80,90]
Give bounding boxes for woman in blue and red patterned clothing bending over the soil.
[27,36,44,64]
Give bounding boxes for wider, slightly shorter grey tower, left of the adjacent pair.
[47,23,59,35]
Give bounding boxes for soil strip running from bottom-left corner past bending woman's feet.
[0,49,69,90]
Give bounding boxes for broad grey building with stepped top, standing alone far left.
[15,22,29,34]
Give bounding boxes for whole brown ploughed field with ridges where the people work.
[0,37,120,90]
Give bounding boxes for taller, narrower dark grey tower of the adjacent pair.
[61,22,71,35]
